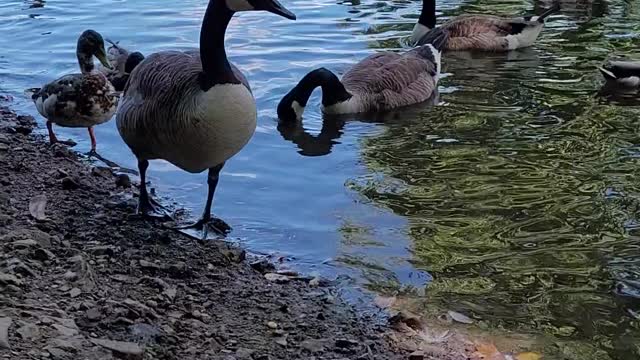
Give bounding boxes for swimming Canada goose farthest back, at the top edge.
[411,0,560,51]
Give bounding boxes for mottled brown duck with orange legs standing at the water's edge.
[31,30,118,153]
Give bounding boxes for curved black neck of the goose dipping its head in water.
[296,68,351,107]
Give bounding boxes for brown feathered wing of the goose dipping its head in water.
[342,47,437,111]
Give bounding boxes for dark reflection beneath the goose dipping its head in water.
[277,90,440,156]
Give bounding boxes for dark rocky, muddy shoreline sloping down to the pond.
[0,107,408,360]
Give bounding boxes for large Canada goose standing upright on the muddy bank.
[116,0,296,238]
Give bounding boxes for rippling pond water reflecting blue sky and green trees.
[0,0,640,359]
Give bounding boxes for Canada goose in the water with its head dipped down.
[278,28,447,121]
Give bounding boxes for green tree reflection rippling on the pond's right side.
[351,1,640,359]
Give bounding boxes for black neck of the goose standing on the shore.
[200,0,240,91]
